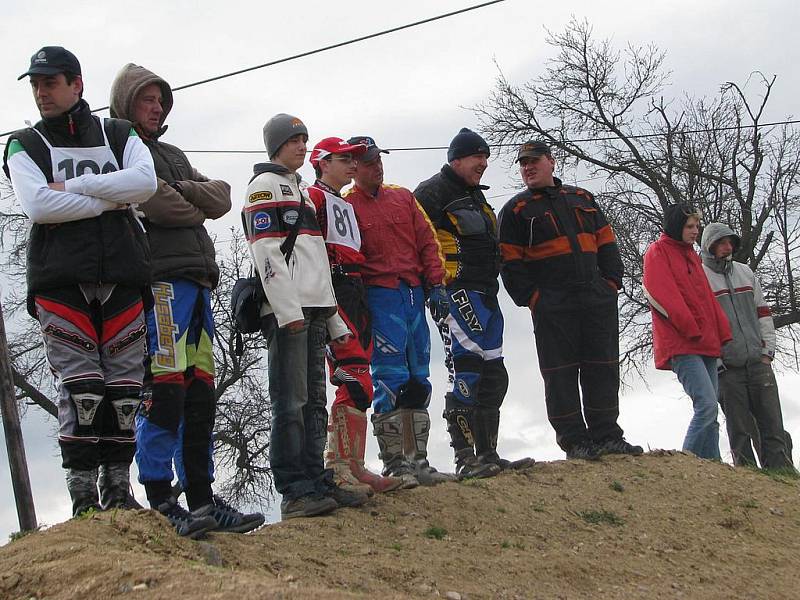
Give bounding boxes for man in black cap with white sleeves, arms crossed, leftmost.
[3,46,156,515]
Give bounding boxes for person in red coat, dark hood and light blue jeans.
[643,204,732,460]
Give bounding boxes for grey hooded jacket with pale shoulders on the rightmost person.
[700,223,775,367]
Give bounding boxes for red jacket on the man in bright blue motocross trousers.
[345,184,444,288]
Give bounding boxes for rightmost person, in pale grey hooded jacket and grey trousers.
[700,223,793,469]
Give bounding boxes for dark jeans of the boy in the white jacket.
[263,310,328,500]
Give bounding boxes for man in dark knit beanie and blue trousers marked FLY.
[414,128,533,477]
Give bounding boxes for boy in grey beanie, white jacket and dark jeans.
[242,113,367,519]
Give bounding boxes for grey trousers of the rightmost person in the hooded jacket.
[719,362,792,469]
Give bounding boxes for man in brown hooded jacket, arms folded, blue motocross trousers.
[110,64,264,537]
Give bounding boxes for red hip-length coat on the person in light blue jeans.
[643,233,732,370]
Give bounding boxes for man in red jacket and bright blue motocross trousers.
[347,136,453,487]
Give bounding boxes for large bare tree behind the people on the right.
[474,19,800,373]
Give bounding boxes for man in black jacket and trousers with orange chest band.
[499,141,642,460]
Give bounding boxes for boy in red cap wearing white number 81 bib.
[308,137,402,494]
